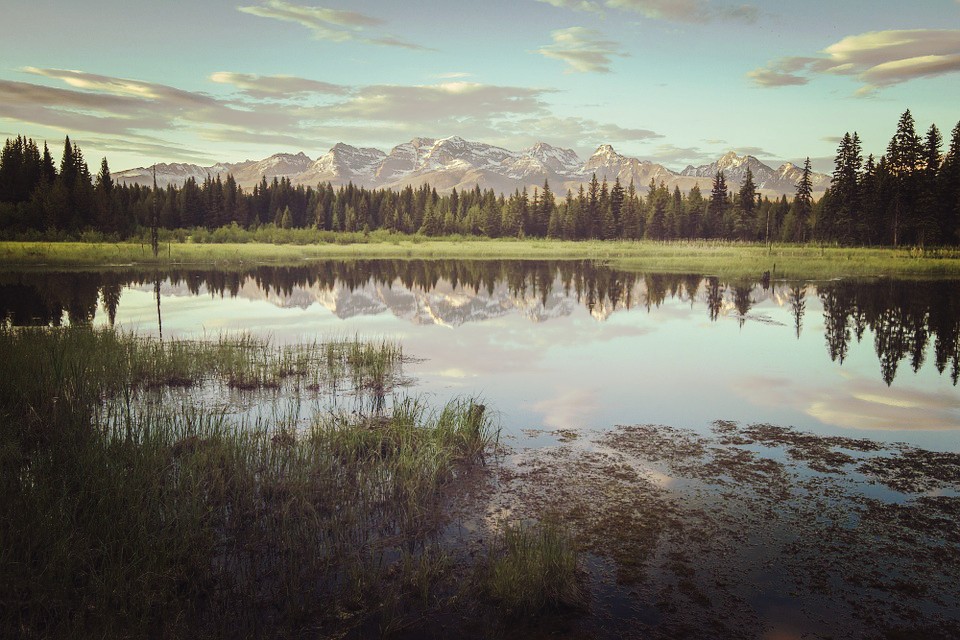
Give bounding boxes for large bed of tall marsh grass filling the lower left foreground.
[0,327,497,638]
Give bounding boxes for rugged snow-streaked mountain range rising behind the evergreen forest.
[113,136,830,196]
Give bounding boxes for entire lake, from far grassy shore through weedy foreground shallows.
[0,260,960,638]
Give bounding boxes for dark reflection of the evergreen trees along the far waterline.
[0,260,960,385]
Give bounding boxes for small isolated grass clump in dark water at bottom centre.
[482,520,586,617]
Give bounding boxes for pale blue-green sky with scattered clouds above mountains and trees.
[0,0,960,172]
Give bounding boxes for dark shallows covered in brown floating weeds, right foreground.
[478,421,960,638]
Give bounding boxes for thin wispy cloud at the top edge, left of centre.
[237,0,428,50]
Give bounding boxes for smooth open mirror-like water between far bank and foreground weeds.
[0,260,960,451]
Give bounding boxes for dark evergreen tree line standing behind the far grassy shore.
[0,111,960,245]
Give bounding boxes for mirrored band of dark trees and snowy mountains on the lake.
[0,260,960,386]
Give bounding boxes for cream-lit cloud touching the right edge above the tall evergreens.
[747,29,960,96]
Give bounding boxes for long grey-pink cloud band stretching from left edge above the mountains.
[0,68,662,162]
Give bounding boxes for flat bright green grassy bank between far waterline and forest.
[0,232,960,278]
